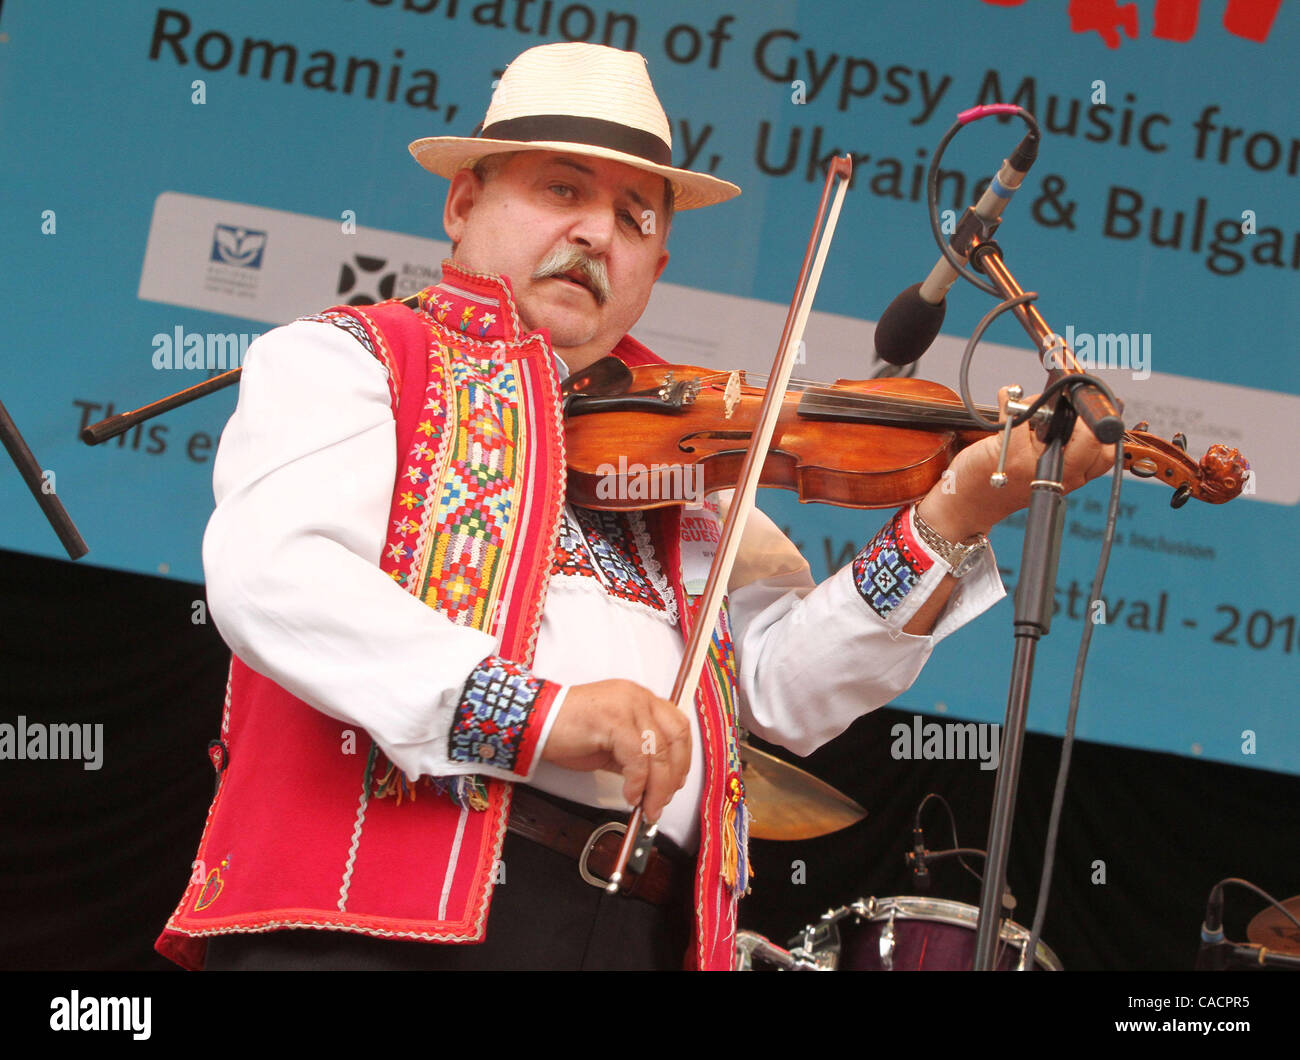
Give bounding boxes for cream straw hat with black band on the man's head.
[411,43,740,209]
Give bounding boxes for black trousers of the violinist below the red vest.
[205,796,694,972]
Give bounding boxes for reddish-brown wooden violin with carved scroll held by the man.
[564,358,1249,510]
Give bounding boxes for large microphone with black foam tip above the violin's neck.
[875,127,1039,364]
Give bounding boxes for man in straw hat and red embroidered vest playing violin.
[159,44,1112,969]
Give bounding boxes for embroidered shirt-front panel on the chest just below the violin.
[551,506,677,622]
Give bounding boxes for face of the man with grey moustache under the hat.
[443,151,668,371]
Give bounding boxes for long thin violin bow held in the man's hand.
[606,156,853,895]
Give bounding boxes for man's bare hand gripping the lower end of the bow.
[542,680,690,822]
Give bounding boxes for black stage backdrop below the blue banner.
[0,551,1300,970]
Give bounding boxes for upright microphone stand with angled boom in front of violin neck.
[953,227,1125,972]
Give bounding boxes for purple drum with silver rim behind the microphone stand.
[790,897,1061,972]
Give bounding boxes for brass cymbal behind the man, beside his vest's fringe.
[740,740,867,839]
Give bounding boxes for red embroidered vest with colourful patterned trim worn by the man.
[156,263,748,970]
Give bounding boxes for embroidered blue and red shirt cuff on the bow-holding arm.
[449,656,562,780]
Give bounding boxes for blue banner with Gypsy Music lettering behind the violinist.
[0,0,1300,771]
